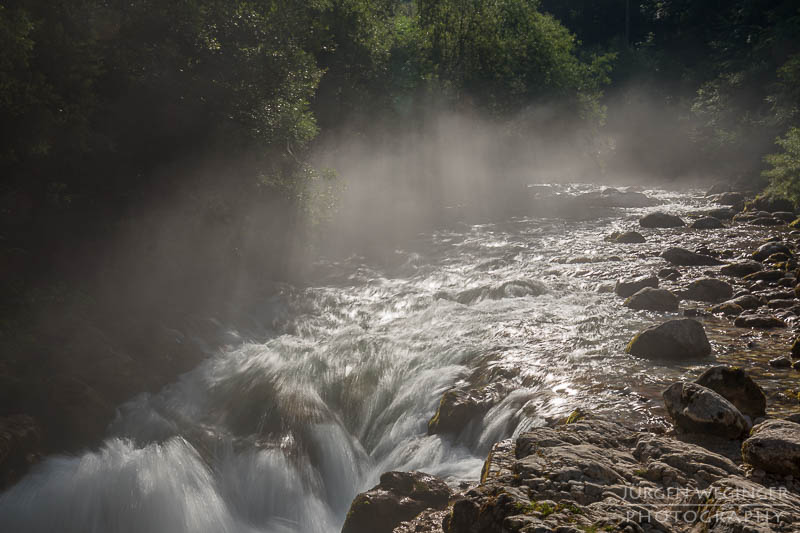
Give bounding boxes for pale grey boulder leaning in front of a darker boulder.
[663,382,749,439]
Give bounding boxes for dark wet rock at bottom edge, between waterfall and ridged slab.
[342,472,452,533]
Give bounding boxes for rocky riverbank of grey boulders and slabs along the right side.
[343,186,800,533]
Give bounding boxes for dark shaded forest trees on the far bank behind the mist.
[0,0,800,466]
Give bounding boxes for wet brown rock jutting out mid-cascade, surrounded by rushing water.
[428,383,503,435]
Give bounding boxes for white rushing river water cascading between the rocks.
[0,186,800,533]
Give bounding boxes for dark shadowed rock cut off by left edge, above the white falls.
[0,415,43,490]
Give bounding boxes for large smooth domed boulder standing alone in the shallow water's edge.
[625,318,711,360]
